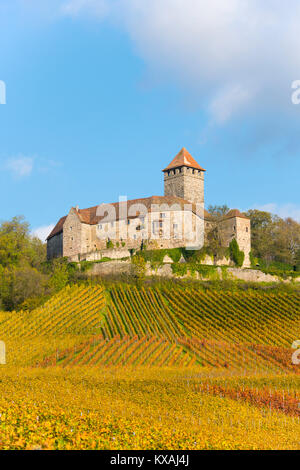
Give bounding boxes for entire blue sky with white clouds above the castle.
[0,0,300,239]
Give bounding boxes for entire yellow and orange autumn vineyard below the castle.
[0,284,300,449]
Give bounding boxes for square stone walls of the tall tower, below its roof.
[164,167,204,204]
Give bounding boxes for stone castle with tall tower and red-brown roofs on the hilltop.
[47,148,251,267]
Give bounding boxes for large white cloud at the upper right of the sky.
[59,0,300,123]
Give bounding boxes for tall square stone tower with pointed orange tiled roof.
[163,148,205,205]
